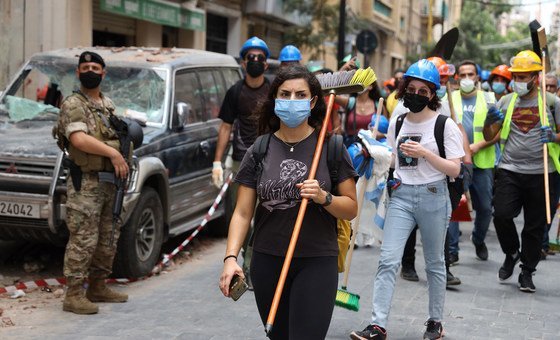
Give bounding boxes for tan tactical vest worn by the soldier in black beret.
[60,93,120,172]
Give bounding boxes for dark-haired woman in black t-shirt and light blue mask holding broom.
[220,66,357,339]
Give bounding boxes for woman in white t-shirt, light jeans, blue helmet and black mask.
[350,59,464,339]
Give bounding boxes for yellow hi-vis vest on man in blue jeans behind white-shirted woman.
[451,90,496,169]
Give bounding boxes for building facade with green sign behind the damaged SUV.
[0,0,297,88]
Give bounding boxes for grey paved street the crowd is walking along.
[0,216,560,340]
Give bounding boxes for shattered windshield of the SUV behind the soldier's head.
[0,60,167,125]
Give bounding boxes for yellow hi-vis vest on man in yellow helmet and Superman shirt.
[500,90,560,172]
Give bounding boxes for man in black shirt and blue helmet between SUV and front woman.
[212,37,270,286]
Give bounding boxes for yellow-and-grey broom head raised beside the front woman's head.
[317,67,377,94]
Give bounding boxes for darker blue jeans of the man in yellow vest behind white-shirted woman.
[449,168,494,254]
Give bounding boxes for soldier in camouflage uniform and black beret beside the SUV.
[55,52,129,314]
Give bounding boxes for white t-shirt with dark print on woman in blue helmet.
[387,113,465,185]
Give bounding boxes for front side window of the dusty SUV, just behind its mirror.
[173,71,204,124]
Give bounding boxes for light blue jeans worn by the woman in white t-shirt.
[372,180,451,328]
